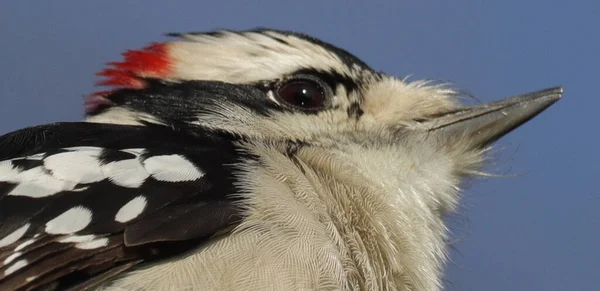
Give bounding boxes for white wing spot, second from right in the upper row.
[101,159,150,188]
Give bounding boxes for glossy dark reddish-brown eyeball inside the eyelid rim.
[279,81,324,108]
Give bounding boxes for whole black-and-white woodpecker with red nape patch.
[0,29,562,290]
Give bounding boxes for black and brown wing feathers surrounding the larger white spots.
[0,122,249,290]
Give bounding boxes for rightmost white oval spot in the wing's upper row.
[144,155,204,182]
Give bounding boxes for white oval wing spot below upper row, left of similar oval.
[46,206,92,234]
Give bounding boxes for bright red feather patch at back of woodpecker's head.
[85,43,171,113]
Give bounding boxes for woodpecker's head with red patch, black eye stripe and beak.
[86,29,562,212]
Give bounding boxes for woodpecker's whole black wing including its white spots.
[0,123,241,290]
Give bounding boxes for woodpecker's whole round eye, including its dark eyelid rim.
[277,79,327,110]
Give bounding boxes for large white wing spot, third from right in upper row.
[44,147,105,184]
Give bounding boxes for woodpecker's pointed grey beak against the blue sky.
[419,87,563,147]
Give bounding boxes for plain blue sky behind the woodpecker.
[0,0,600,290]
